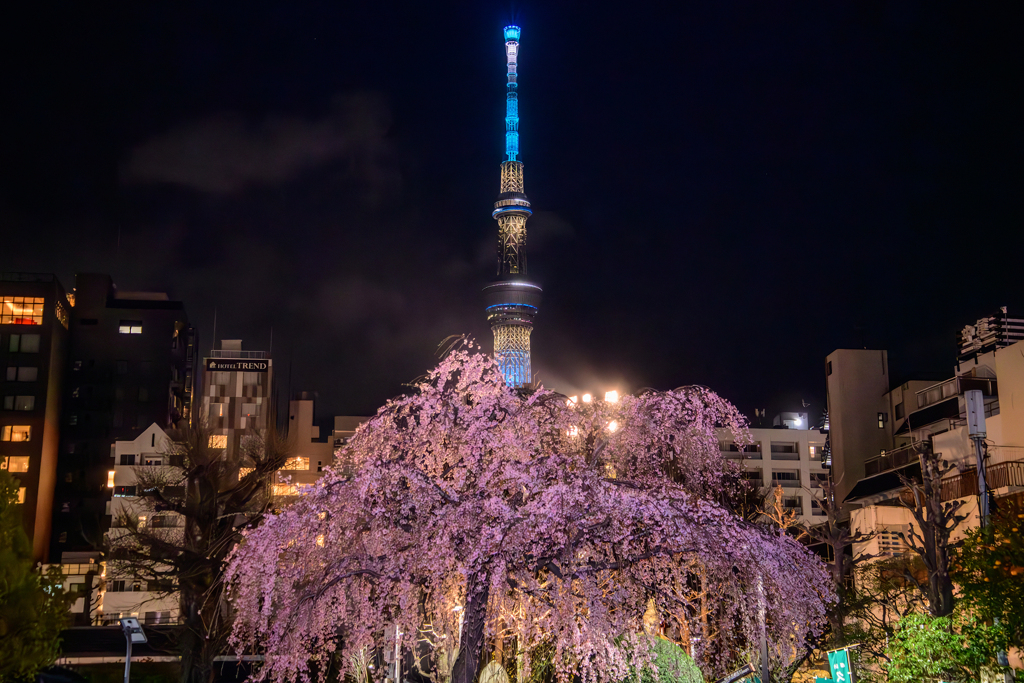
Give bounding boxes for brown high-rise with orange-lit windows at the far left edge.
[0,272,72,562]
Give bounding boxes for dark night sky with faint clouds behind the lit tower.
[0,1,1024,428]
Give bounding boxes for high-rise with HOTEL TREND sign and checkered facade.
[200,339,273,467]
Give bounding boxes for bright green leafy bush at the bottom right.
[885,608,1006,683]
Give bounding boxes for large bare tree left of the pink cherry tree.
[108,426,288,683]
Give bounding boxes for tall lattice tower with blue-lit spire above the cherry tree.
[483,26,541,387]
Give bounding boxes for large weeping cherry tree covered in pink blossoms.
[226,342,834,683]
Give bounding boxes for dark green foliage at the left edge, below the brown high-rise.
[0,471,68,683]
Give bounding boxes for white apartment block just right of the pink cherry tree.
[719,418,828,525]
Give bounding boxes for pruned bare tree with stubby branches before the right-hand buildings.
[899,442,967,616]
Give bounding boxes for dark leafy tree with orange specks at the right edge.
[953,500,1024,647]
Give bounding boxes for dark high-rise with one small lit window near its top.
[50,273,197,562]
